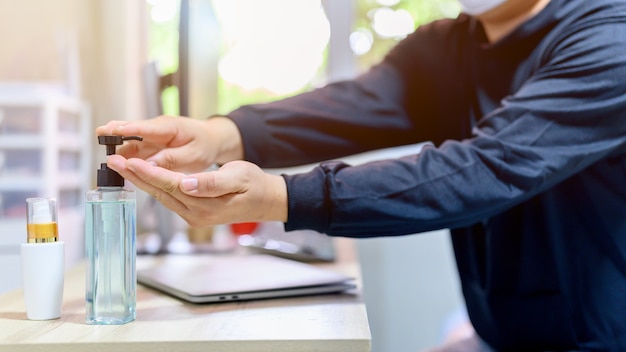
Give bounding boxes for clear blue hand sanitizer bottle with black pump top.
[85,136,142,325]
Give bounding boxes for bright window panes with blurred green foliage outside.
[147,0,459,115]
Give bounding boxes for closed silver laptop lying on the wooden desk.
[137,254,356,303]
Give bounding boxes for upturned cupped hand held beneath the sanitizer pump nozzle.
[107,155,287,227]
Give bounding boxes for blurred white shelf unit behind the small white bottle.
[0,83,92,292]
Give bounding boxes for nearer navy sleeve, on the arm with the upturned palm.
[285,19,626,237]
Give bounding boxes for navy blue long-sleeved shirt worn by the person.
[229,0,626,351]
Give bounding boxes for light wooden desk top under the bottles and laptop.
[0,239,371,352]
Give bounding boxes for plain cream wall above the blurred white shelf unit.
[0,0,147,182]
